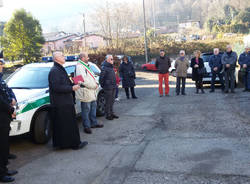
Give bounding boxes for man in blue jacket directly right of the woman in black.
[209,48,225,93]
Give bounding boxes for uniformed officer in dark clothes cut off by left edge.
[0,59,17,182]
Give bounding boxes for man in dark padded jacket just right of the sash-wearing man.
[99,56,119,120]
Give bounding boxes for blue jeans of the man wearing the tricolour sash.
[81,101,97,128]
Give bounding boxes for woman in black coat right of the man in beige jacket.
[191,50,205,93]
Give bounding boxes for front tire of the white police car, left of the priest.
[32,111,52,144]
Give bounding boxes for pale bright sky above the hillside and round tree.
[0,0,139,33]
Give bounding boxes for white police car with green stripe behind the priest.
[6,62,105,144]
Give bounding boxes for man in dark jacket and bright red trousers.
[155,50,171,97]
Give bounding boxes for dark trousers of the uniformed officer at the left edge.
[0,113,11,177]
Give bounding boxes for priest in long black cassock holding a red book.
[49,52,88,150]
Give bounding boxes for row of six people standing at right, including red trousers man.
[155,45,250,97]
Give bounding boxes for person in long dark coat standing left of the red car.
[119,56,137,99]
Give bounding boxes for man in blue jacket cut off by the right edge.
[239,46,250,92]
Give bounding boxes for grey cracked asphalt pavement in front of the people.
[10,72,250,184]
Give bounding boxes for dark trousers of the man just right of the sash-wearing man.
[104,88,116,117]
